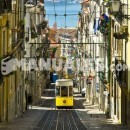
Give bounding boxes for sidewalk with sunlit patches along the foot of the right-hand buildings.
[73,88,129,130]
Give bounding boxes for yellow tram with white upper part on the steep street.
[55,79,73,107]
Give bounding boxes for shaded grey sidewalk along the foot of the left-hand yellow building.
[0,109,45,130]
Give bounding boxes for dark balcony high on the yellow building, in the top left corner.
[0,0,12,14]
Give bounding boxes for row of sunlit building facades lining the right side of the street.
[78,0,130,125]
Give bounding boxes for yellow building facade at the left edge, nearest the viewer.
[0,0,25,122]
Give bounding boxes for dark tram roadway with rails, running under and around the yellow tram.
[34,83,84,130]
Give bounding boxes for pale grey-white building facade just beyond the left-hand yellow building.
[24,1,50,105]
